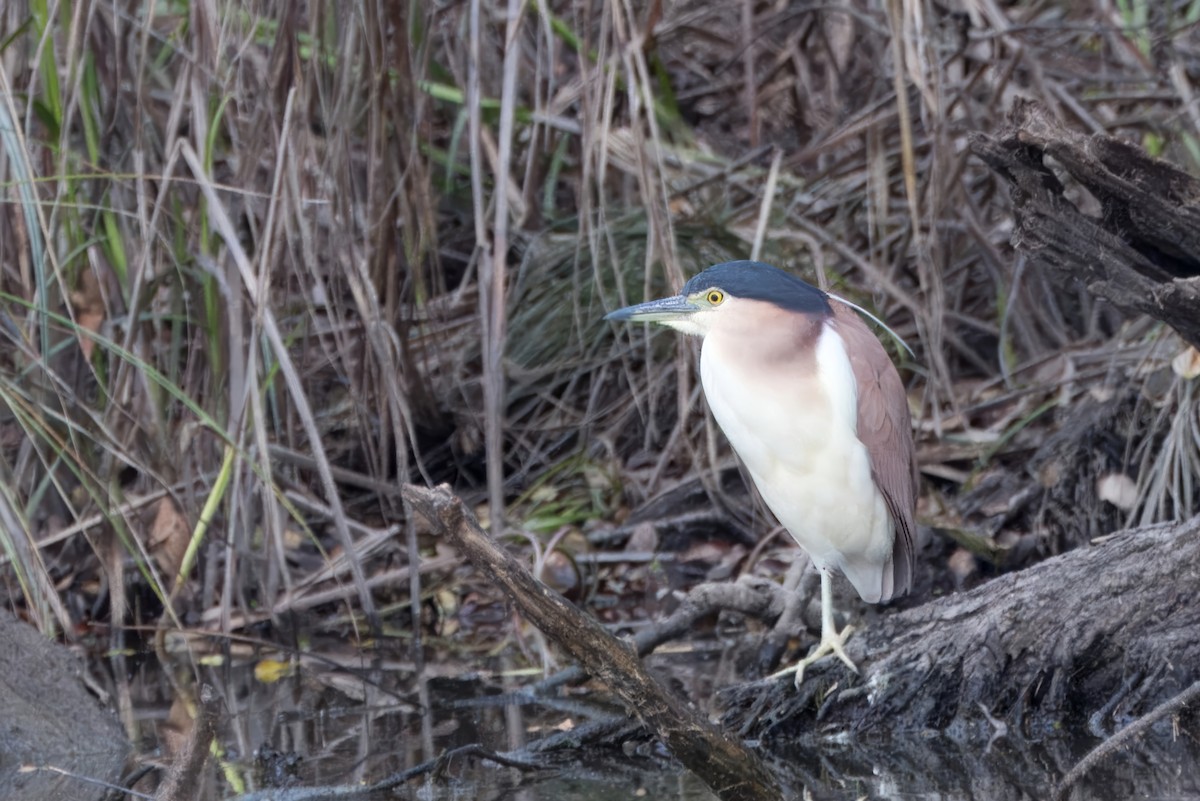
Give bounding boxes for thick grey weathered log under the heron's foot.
[722,518,1200,742]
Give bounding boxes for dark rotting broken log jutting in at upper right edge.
[971,102,1200,347]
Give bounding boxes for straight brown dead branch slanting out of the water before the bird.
[402,484,782,801]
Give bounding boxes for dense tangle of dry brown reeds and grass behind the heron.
[0,0,1200,661]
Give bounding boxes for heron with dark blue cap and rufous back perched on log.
[605,261,918,687]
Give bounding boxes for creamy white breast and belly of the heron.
[700,330,893,601]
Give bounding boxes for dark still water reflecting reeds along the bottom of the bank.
[108,647,1200,801]
